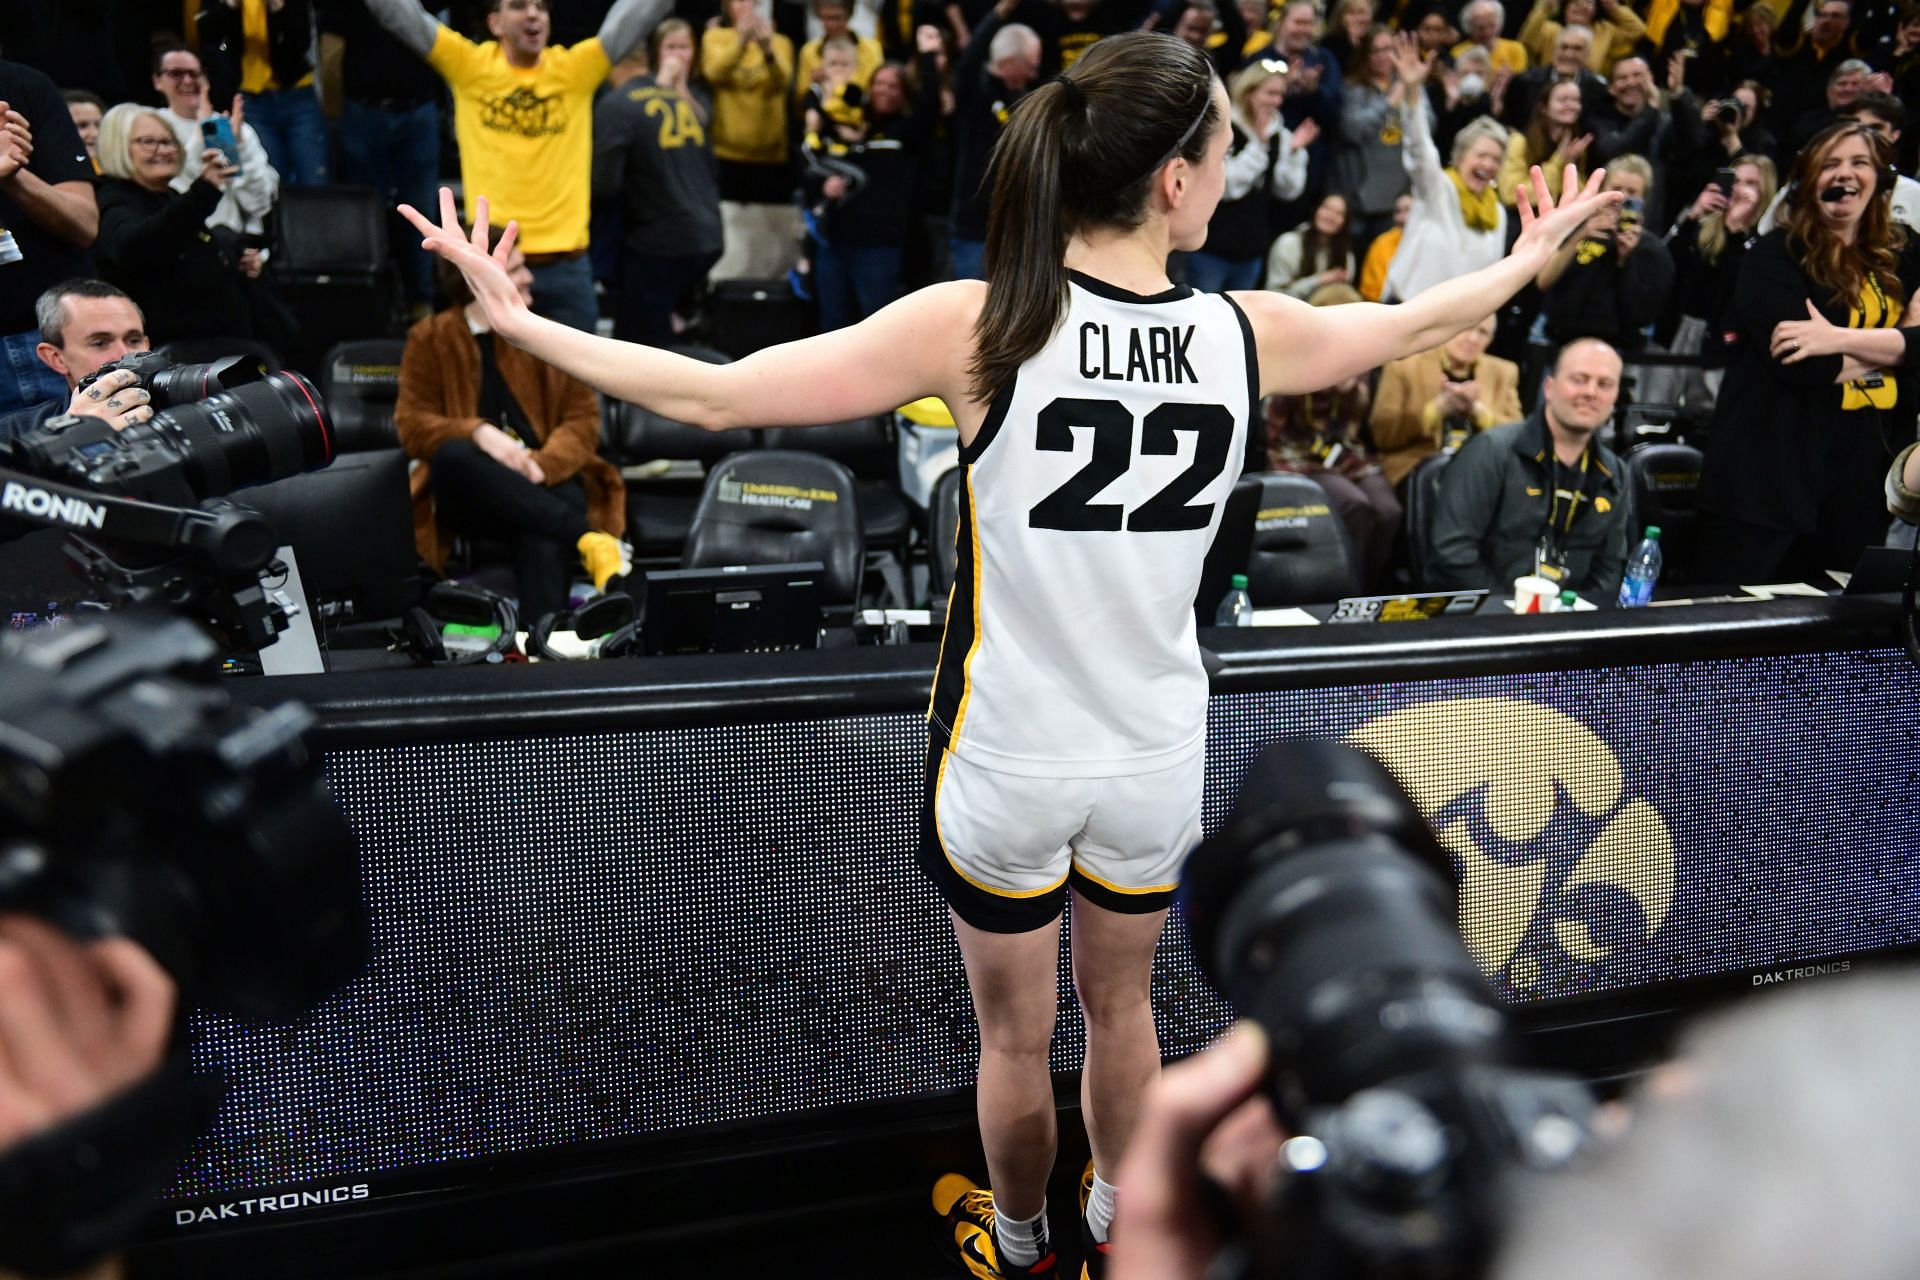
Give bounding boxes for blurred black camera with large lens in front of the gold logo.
[1183,743,1592,1280]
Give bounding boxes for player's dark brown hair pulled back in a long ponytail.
[968,31,1223,401]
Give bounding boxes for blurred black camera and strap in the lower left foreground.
[0,612,371,1274]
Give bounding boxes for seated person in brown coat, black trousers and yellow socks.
[394,240,626,622]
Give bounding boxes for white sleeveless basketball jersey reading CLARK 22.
[929,274,1260,777]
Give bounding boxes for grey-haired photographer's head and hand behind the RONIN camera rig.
[0,280,154,441]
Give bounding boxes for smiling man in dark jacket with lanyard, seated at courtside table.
[1430,338,1628,603]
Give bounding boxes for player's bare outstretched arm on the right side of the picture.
[1233,165,1620,395]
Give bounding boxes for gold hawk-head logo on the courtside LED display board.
[1346,699,1674,992]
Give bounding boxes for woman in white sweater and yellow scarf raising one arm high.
[1386,35,1507,301]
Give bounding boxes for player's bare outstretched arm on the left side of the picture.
[399,188,987,432]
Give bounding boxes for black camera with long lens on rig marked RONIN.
[0,353,334,651]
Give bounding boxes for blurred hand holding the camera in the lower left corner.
[0,915,175,1150]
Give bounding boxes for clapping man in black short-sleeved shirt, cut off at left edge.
[0,61,100,413]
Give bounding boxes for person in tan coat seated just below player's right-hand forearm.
[1369,317,1526,486]
